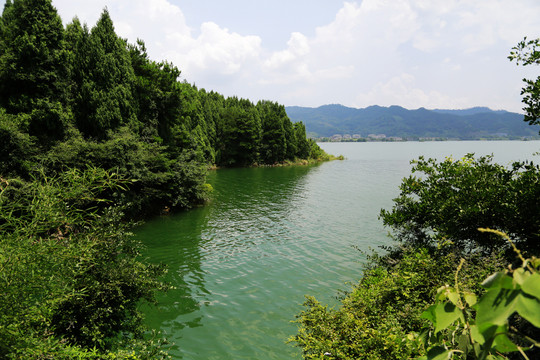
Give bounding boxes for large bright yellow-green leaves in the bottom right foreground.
[421,232,540,360]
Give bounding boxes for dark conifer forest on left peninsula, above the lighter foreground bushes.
[0,0,325,211]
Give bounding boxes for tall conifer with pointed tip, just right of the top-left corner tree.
[72,9,136,139]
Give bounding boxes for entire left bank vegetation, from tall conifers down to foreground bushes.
[0,0,327,359]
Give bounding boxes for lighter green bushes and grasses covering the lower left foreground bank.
[0,168,170,359]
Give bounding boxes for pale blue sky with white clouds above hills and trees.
[0,0,540,112]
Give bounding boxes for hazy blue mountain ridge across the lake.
[286,104,540,140]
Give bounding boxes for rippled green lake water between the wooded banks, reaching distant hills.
[135,141,540,360]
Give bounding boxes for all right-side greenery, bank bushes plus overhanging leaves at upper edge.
[292,39,540,360]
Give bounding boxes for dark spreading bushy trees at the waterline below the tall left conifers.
[40,127,208,216]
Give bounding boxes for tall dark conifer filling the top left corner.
[0,0,67,141]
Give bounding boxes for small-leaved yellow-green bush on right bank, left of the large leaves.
[291,248,498,359]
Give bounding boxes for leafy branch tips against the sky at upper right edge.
[508,37,540,129]
